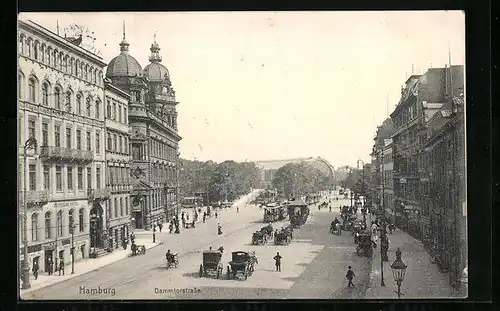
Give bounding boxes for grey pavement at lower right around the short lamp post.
[366,229,452,299]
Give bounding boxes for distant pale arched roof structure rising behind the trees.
[255,157,335,187]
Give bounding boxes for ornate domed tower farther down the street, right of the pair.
[144,39,178,132]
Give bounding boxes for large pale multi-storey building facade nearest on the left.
[18,21,108,272]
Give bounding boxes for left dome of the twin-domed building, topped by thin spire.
[106,23,147,104]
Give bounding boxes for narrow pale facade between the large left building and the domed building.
[104,79,131,250]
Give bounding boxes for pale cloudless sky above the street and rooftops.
[19,11,465,167]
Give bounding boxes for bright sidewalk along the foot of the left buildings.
[20,238,163,295]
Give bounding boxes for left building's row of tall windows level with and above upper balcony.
[19,117,102,154]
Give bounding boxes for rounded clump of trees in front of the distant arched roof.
[272,162,335,198]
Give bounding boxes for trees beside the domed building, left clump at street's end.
[179,159,260,202]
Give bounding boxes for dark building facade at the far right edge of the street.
[422,66,468,289]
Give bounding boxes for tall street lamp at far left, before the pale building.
[21,137,38,289]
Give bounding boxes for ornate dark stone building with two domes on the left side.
[106,32,182,230]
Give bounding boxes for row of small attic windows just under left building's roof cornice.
[19,33,103,86]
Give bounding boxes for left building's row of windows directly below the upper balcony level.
[19,164,103,192]
